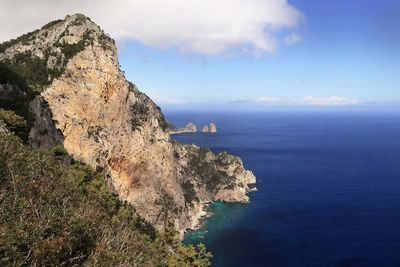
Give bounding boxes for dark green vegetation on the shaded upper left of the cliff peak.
[0,15,97,138]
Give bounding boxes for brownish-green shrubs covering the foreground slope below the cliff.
[0,134,211,266]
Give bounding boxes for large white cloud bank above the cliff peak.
[0,0,304,56]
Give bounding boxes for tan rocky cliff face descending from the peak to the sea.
[0,14,255,237]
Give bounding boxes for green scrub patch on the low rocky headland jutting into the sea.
[184,147,234,192]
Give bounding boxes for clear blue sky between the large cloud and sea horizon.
[115,0,400,108]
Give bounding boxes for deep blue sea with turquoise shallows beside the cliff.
[166,112,400,266]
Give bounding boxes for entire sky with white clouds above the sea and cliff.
[0,0,400,110]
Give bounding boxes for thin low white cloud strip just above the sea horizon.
[255,96,361,106]
